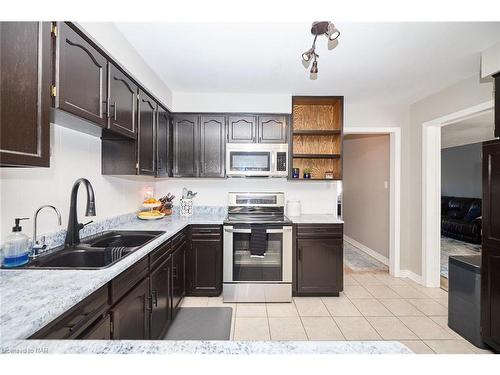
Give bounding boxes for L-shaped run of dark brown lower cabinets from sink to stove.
[30,225,222,340]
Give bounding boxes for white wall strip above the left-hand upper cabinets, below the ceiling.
[78,22,172,110]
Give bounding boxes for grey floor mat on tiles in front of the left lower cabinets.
[164,307,233,340]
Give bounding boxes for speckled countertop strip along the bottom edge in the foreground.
[0,340,413,354]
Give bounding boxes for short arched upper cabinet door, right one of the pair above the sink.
[108,63,137,138]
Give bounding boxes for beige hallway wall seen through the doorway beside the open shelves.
[342,134,390,258]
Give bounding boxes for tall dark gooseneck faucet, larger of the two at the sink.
[64,178,95,246]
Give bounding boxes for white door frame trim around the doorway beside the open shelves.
[344,127,402,277]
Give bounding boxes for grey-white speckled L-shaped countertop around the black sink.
[0,213,226,342]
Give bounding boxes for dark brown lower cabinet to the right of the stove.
[294,225,343,296]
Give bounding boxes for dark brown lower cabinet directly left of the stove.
[188,225,222,296]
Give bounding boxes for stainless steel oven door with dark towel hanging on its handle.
[224,225,292,283]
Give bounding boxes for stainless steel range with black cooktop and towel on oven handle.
[223,193,292,302]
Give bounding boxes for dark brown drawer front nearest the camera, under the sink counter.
[30,284,109,339]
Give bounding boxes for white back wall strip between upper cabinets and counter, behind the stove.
[155,178,337,214]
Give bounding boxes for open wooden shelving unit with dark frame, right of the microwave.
[289,96,344,181]
